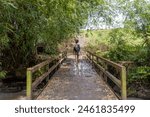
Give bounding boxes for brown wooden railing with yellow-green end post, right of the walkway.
[87,51,127,99]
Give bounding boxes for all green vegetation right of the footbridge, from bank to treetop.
[83,0,150,98]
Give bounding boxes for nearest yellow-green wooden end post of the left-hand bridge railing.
[26,68,32,99]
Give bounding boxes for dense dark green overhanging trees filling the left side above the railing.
[0,0,103,77]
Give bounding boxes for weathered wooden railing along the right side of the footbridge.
[87,51,127,99]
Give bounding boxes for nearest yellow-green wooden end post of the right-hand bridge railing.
[121,66,127,100]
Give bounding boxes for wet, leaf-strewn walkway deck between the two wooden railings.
[37,56,117,100]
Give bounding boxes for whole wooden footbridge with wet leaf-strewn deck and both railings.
[26,52,127,100]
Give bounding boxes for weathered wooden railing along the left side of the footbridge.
[26,51,67,99]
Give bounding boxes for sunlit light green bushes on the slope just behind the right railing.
[85,28,142,61]
